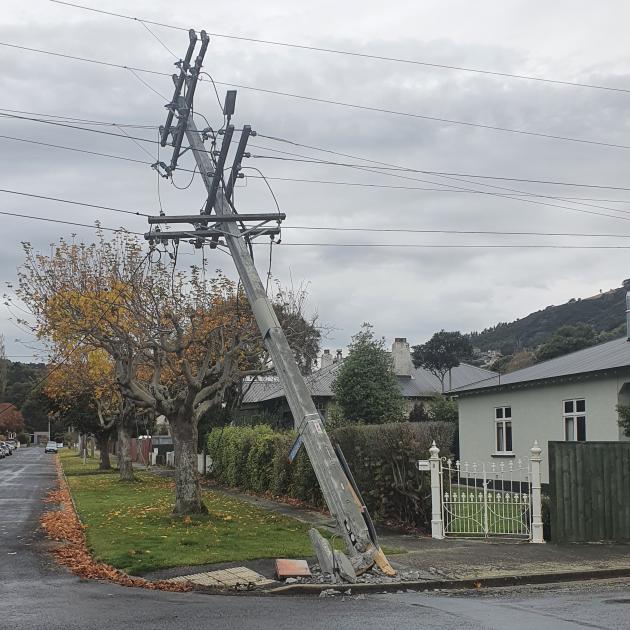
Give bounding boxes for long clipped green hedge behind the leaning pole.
[208,422,455,528]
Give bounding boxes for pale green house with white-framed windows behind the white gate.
[451,324,630,483]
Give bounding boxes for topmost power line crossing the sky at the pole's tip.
[50,0,630,93]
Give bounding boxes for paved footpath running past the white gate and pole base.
[136,468,630,594]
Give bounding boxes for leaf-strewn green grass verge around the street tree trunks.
[59,449,324,575]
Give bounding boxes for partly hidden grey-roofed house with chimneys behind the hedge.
[241,337,496,427]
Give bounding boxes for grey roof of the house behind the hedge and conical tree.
[243,362,496,404]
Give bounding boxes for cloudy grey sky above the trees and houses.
[0,0,630,360]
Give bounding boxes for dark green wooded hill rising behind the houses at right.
[470,279,630,354]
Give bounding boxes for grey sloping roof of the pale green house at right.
[451,337,630,394]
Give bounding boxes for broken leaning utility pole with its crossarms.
[145,30,395,574]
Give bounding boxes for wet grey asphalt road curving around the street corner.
[0,448,630,630]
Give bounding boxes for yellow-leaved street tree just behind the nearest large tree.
[17,232,152,481]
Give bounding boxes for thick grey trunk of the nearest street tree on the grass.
[169,413,208,516]
